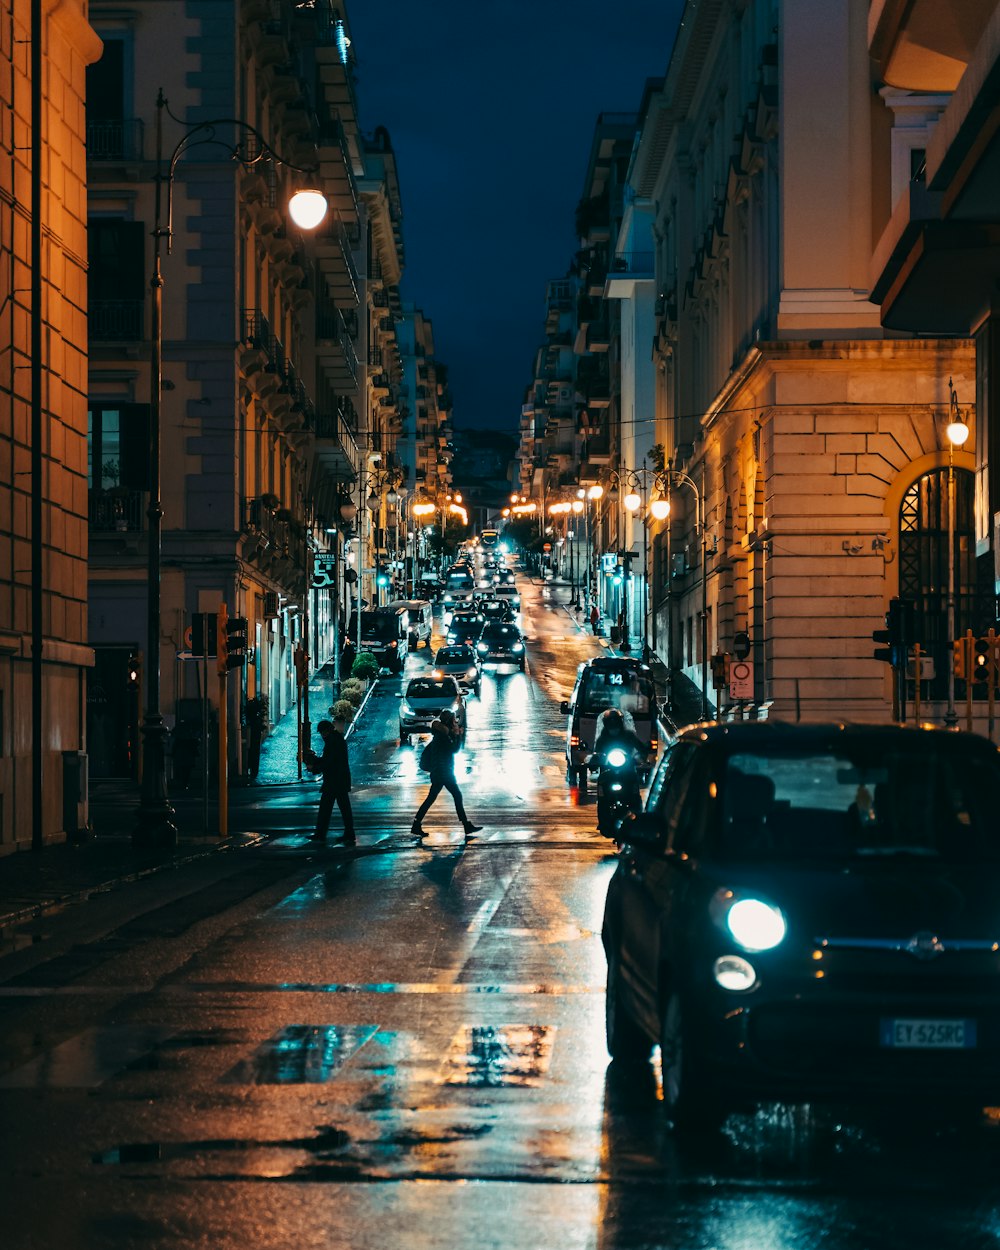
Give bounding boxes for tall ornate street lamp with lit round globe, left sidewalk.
[133,89,326,846]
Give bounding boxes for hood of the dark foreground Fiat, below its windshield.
[701,855,1000,941]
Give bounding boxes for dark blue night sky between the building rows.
[348,0,684,433]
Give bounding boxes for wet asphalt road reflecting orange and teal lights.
[0,572,1000,1250]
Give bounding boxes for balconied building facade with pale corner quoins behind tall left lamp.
[88,0,403,775]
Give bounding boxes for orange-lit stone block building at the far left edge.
[0,0,101,855]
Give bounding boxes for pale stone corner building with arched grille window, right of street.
[619,0,980,720]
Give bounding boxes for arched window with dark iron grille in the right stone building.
[899,468,983,699]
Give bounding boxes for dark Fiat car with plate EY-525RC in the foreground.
[603,723,1000,1128]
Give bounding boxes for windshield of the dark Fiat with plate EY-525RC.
[716,739,1000,860]
